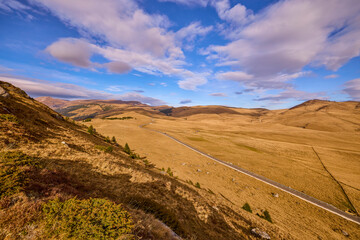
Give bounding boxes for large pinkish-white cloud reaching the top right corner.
[204,0,360,88]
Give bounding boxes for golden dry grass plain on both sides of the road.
[91,110,360,239]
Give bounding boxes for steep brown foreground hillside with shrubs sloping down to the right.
[0,82,292,239]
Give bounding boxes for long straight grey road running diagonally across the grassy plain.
[139,123,360,225]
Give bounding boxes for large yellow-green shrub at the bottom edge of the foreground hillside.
[43,198,134,239]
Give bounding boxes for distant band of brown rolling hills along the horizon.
[37,97,360,132]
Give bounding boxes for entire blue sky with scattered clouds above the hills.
[0,0,360,109]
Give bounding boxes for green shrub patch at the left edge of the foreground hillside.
[0,151,40,198]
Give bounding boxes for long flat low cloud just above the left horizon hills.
[0,75,165,105]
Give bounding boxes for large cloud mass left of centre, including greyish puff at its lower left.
[32,0,212,90]
